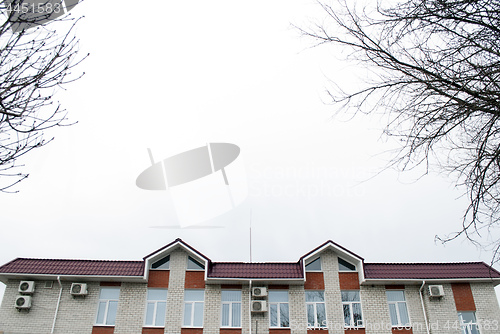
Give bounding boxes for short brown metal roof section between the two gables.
[208,262,304,279]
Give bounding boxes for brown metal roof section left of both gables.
[0,258,144,276]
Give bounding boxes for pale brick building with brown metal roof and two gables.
[0,239,500,334]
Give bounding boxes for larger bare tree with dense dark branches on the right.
[299,0,500,261]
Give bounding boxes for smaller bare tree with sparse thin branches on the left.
[0,0,86,192]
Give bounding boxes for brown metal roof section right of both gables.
[364,262,500,279]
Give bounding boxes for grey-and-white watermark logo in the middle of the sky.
[136,143,248,228]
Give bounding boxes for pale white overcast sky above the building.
[0,0,500,298]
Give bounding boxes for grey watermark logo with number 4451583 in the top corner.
[1,0,79,32]
